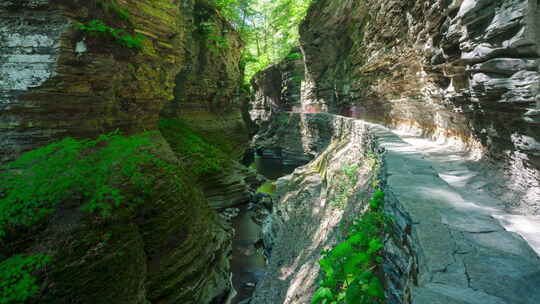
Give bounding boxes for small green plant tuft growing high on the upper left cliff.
[77,20,144,50]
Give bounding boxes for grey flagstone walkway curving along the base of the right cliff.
[372,125,540,304]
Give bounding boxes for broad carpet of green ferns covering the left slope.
[0,133,161,238]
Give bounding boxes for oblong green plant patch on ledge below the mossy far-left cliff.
[159,119,231,179]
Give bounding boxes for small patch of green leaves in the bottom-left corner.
[0,254,50,304]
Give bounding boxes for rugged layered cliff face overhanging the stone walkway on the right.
[300,0,540,213]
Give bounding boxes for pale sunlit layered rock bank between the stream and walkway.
[251,113,378,304]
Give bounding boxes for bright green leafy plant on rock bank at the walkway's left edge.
[311,190,390,304]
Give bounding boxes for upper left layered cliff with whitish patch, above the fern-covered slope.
[0,0,245,159]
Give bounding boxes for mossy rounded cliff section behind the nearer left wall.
[162,1,249,154]
